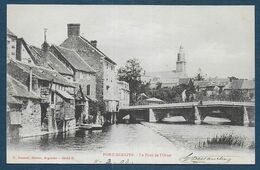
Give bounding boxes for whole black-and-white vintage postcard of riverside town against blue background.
[6,4,255,164]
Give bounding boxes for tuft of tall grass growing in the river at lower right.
[196,134,255,149]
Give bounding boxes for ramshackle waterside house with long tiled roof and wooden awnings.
[7,60,75,134]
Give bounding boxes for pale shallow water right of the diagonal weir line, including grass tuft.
[141,122,255,151]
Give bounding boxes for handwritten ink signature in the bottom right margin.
[180,153,234,163]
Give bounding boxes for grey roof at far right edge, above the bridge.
[225,79,255,90]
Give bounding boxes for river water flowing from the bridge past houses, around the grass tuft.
[8,117,255,163]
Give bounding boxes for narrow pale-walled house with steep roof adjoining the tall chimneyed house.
[51,45,96,124]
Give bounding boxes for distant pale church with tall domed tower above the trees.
[141,46,187,89]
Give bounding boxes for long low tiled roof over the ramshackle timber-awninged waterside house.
[8,61,74,87]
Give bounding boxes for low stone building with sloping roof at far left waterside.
[6,75,41,139]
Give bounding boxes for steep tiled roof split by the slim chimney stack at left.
[30,46,73,75]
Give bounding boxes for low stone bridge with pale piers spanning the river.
[116,101,255,126]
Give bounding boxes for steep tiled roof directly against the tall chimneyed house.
[51,45,96,73]
